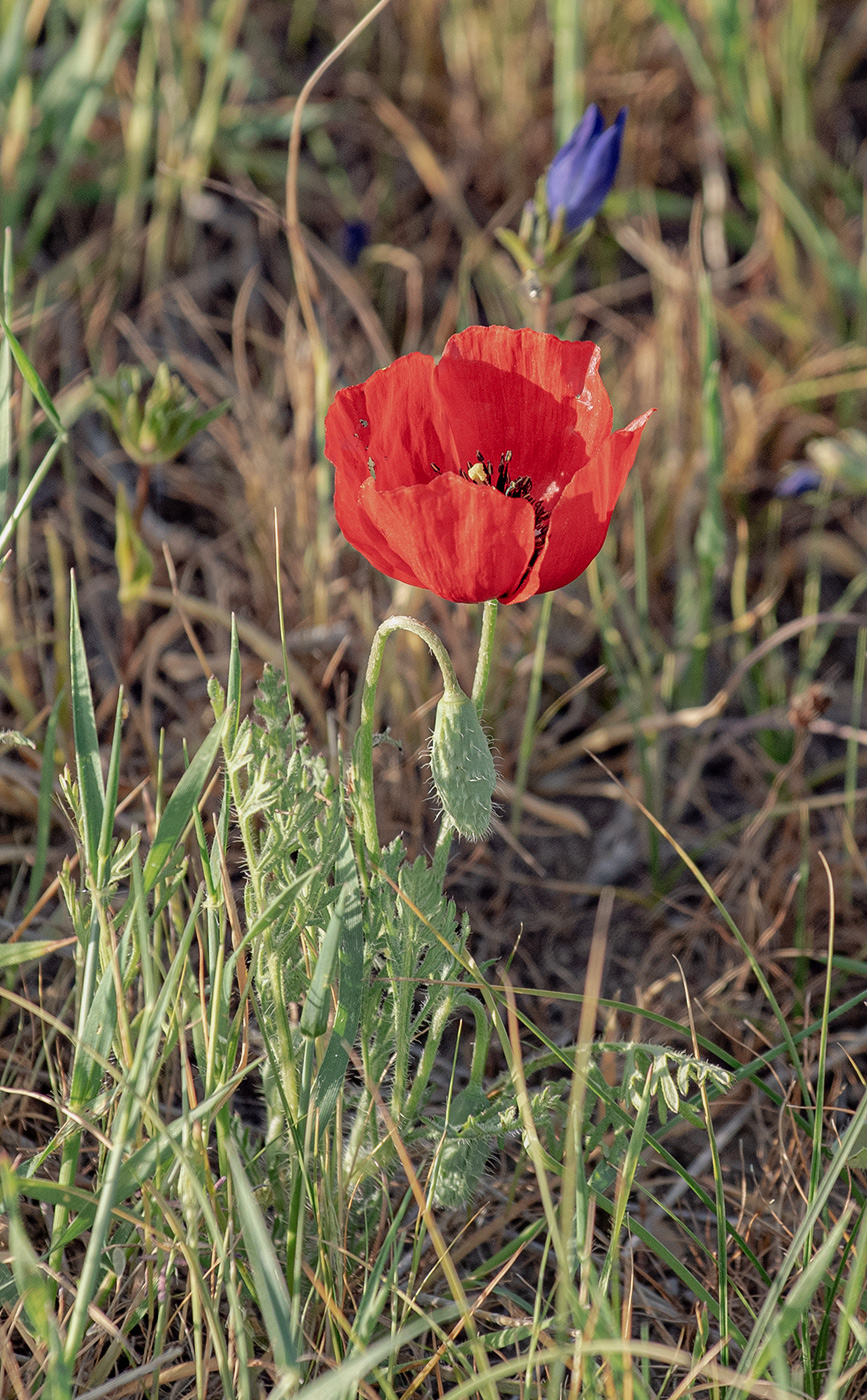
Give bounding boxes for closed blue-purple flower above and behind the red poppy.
[546,102,626,234]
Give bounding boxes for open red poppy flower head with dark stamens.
[325,326,653,603]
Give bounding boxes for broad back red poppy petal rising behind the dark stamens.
[434,326,611,503]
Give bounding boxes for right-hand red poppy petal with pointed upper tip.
[518,409,654,602]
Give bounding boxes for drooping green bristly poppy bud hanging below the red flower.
[430,685,497,841]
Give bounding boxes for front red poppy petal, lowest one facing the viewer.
[361,473,535,603]
